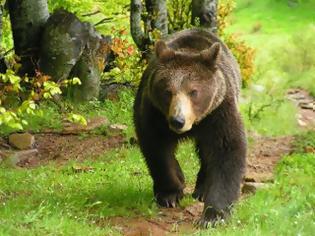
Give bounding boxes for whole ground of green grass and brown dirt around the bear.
[0,0,315,236]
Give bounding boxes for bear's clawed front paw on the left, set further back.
[155,190,184,208]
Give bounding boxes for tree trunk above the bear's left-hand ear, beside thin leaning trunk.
[145,0,168,35]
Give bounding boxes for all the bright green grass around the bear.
[0,0,315,236]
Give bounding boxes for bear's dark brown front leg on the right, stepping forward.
[199,115,246,227]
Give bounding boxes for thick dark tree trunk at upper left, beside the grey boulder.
[8,0,49,75]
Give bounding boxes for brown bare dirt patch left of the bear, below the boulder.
[0,133,126,167]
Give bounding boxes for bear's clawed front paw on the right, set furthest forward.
[196,207,227,229]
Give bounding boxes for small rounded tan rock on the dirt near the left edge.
[9,133,35,150]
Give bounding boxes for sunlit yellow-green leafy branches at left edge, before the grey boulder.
[0,69,86,135]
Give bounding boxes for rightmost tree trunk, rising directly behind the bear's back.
[191,0,218,33]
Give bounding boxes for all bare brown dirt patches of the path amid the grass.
[0,89,315,236]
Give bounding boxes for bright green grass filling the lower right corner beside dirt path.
[200,154,315,235]
